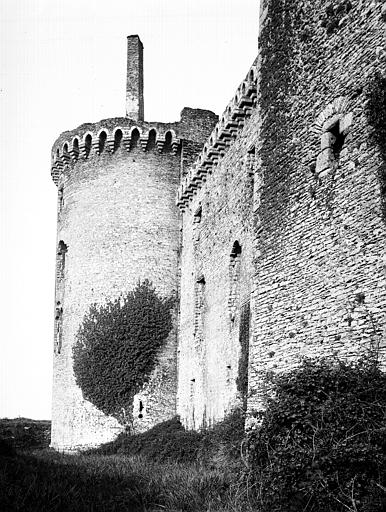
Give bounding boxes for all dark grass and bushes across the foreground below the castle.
[0,356,386,512]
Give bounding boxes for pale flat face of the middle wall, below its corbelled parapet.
[178,119,254,428]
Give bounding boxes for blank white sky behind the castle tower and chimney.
[0,0,259,419]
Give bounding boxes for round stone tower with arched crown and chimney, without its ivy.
[51,36,217,451]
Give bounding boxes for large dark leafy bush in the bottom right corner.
[248,360,386,512]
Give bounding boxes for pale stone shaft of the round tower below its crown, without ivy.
[53,144,179,448]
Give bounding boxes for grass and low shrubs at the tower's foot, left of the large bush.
[0,416,256,512]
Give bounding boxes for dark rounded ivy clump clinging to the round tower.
[73,280,174,423]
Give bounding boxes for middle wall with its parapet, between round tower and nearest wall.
[177,63,256,429]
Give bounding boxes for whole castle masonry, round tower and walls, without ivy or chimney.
[53,4,386,448]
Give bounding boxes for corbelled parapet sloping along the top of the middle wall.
[177,60,257,209]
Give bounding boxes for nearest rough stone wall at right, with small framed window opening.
[249,0,386,409]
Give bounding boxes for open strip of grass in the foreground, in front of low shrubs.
[0,449,253,512]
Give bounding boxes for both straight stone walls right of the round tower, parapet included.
[178,0,386,427]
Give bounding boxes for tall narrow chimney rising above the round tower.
[126,36,144,121]
